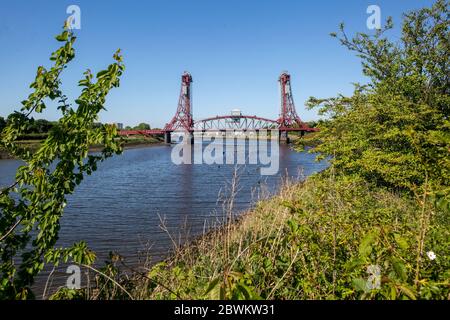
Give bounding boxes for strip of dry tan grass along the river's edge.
[126,174,300,299]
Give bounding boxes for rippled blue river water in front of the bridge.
[0,142,327,293]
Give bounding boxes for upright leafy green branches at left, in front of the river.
[0,27,124,299]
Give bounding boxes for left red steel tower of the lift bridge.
[164,71,194,143]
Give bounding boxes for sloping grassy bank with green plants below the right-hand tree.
[55,170,450,299]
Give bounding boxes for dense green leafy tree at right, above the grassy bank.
[308,0,450,200]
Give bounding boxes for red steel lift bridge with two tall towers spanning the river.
[119,72,318,143]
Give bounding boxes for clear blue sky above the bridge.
[0,0,432,127]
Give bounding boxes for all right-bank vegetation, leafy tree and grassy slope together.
[75,0,450,299]
